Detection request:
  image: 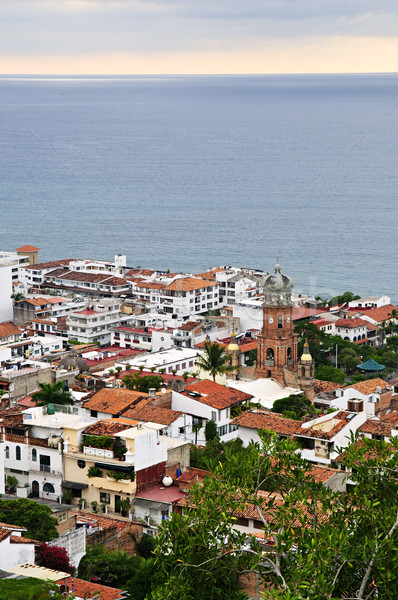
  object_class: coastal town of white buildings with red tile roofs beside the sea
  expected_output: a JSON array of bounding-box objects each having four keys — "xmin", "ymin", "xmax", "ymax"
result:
[{"xmin": 0, "ymin": 245, "xmax": 398, "ymax": 600}]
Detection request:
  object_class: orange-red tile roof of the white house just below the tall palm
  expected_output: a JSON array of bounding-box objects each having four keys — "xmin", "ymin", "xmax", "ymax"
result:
[{"xmin": 180, "ymin": 379, "xmax": 253, "ymax": 410}]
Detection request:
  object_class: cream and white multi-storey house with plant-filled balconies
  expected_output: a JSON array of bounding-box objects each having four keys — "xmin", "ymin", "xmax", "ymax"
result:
[{"xmin": 63, "ymin": 417, "xmax": 167, "ymax": 513}]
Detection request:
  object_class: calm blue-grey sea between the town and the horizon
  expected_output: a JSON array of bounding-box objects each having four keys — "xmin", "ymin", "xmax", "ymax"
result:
[{"xmin": 0, "ymin": 75, "xmax": 398, "ymax": 301}]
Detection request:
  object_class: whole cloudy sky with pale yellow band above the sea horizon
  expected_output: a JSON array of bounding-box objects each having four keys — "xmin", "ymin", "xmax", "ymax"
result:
[{"xmin": 0, "ymin": 0, "xmax": 398, "ymax": 74}]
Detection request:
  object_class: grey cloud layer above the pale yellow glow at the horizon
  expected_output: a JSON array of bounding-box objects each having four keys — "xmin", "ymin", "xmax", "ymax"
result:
[{"xmin": 0, "ymin": 0, "xmax": 398, "ymax": 71}]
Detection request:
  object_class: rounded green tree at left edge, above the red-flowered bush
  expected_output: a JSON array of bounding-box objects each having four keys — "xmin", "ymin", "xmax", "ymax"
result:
[{"xmin": 0, "ymin": 498, "xmax": 58, "ymax": 542}]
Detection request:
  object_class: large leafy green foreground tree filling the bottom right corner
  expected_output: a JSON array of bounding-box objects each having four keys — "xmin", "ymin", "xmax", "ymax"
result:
[{"xmin": 149, "ymin": 432, "xmax": 398, "ymax": 600}]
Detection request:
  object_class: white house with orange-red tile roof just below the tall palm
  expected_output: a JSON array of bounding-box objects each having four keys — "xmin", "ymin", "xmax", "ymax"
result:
[{"xmin": 172, "ymin": 379, "xmax": 253, "ymax": 444}]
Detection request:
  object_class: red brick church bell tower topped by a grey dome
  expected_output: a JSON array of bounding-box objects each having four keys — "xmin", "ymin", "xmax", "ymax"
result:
[{"xmin": 256, "ymin": 264, "xmax": 297, "ymax": 385}]
